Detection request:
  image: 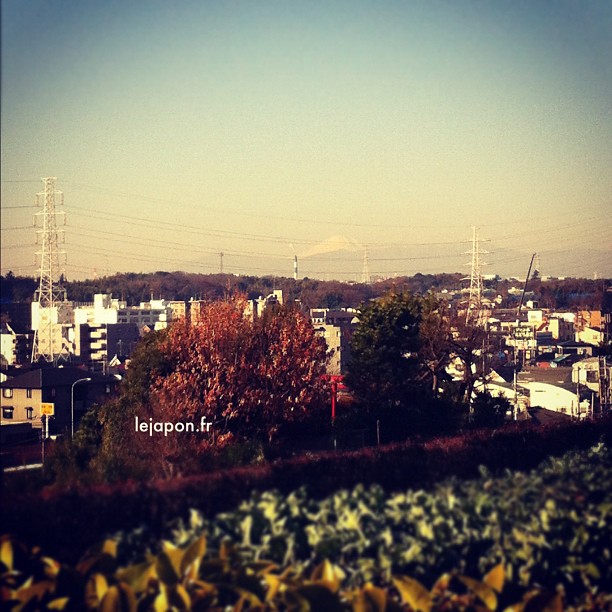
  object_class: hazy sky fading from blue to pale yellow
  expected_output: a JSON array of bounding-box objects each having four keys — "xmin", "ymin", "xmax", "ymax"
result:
[{"xmin": 0, "ymin": 0, "xmax": 612, "ymax": 281}]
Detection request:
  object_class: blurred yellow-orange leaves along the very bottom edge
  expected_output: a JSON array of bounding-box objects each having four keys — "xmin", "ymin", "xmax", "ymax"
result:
[{"xmin": 0, "ymin": 536, "xmax": 612, "ymax": 612}]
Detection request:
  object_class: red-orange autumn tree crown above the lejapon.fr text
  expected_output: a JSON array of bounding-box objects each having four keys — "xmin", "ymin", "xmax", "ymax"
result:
[{"xmin": 151, "ymin": 299, "xmax": 326, "ymax": 448}]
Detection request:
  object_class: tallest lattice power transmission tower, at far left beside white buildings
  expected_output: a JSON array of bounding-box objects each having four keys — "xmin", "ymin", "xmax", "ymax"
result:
[{"xmin": 32, "ymin": 177, "xmax": 68, "ymax": 362}]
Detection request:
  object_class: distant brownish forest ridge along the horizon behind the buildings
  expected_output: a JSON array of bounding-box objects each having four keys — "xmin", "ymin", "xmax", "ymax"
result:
[{"xmin": 0, "ymin": 272, "xmax": 612, "ymax": 309}]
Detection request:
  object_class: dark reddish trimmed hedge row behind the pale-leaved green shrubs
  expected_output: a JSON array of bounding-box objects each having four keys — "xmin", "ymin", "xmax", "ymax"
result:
[{"xmin": 0, "ymin": 419, "xmax": 612, "ymax": 561}]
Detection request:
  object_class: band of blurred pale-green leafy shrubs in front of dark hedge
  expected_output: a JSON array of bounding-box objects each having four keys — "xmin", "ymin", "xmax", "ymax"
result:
[{"xmin": 111, "ymin": 445, "xmax": 612, "ymax": 601}]
